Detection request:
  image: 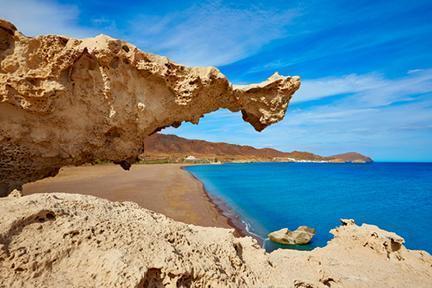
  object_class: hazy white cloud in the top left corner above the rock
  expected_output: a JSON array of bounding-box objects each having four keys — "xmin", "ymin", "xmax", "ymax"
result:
[{"xmin": 0, "ymin": 0, "xmax": 96, "ymax": 38}]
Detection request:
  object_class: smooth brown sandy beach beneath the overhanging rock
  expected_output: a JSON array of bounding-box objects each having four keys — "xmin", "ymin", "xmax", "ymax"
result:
[{"xmin": 23, "ymin": 164, "xmax": 235, "ymax": 228}]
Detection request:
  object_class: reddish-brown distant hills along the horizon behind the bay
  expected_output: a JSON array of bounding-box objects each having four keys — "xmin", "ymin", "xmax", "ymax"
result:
[{"xmin": 141, "ymin": 133, "xmax": 371, "ymax": 162}]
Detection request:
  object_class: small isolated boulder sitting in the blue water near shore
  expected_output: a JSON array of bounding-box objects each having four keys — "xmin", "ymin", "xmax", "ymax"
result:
[{"xmin": 268, "ymin": 226, "xmax": 315, "ymax": 245}]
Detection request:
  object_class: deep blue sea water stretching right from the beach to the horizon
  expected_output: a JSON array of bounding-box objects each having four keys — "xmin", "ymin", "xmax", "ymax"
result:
[{"xmin": 187, "ymin": 163, "xmax": 432, "ymax": 253}]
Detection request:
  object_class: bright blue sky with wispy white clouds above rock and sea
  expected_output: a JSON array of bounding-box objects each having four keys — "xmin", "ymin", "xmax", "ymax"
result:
[{"xmin": 0, "ymin": 0, "xmax": 432, "ymax": 161}]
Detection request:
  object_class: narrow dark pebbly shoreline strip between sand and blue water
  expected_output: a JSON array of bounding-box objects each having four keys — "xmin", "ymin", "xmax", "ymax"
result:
[{"xmin": 180, "ymin": 165, "xmax": 264, "ymax": 246}]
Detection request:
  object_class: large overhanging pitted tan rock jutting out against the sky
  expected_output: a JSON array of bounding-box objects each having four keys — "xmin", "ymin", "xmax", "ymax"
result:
[{"xmin": 0, "ymin": 20, "xmax": 300, "ymax": 195}]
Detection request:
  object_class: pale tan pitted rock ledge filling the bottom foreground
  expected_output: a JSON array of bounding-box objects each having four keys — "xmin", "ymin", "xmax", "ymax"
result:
[{"xmin": 0, "ymin": 193, "xmax": 432, "ymax": 287}]
